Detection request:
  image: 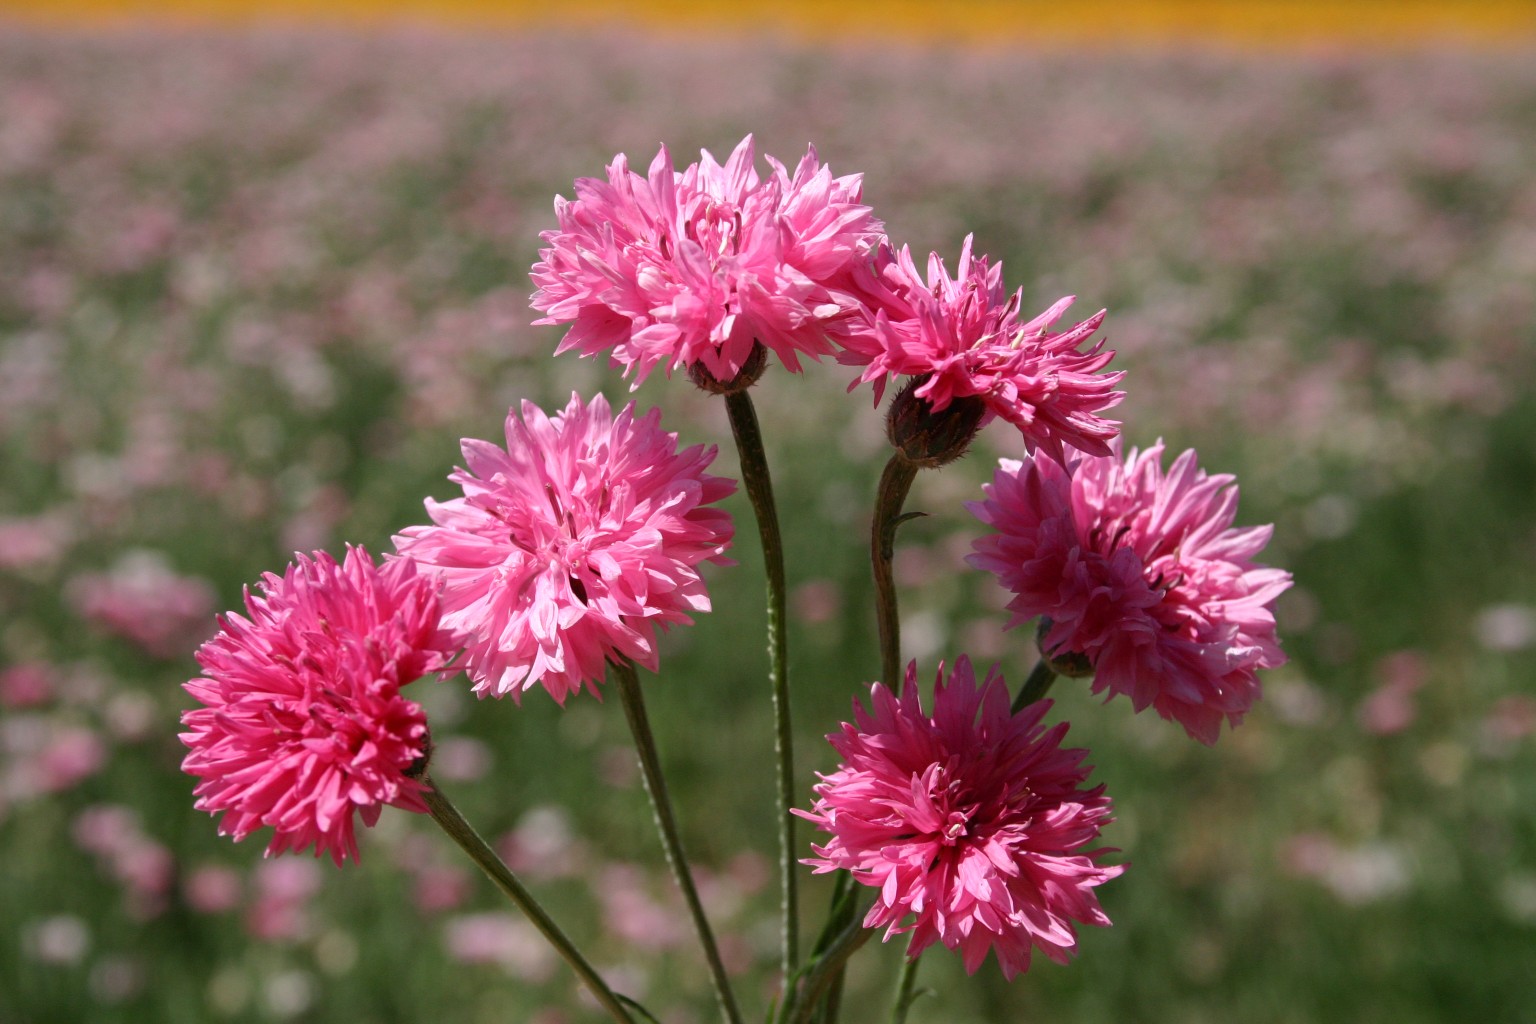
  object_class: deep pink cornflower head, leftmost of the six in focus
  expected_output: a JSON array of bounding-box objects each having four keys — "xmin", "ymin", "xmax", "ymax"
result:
[{"xmin": 181, "ymin": 548, "xmax": 453, "ymax": 864}]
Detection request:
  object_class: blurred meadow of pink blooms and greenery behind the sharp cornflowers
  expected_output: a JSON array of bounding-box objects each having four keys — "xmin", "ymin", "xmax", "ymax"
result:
[{"xmin": 0, "ymin": 23, "xmax": 1536, "ymax": 1024}]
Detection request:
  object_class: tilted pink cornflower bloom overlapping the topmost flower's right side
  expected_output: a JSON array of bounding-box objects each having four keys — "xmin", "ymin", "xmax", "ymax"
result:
[{"xmin": 837, "ymin": 236, "xmax": 1124, "ymax": 457}]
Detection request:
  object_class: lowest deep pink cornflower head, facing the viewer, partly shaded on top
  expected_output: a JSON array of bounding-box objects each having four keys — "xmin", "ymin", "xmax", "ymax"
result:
[{"xmin": 796, "ymin": 657, "xmax": 1124, "ymax": 978}]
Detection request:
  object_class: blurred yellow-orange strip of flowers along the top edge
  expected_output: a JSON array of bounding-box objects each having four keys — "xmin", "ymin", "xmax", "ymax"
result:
[{"xmin": 9, "ymin": 0, "xmax": 1536, "ymax": 48}]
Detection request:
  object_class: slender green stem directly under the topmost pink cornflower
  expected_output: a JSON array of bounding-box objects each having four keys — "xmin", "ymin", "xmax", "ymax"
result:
[{"xmin": 725, "ymin": 390, "xmax": 800, "ymax": 983}]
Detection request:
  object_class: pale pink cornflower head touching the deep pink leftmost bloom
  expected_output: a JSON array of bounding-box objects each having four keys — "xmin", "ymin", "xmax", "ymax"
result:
[{"xmin": 395, "ymin": 395, "xmax": 736, "ymax": 705}]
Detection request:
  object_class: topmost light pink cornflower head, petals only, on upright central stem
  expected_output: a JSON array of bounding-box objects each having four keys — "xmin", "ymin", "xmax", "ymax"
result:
[{"xmin": 531, "ymin": 135, "xmax": 882, "ymax": 385}]
